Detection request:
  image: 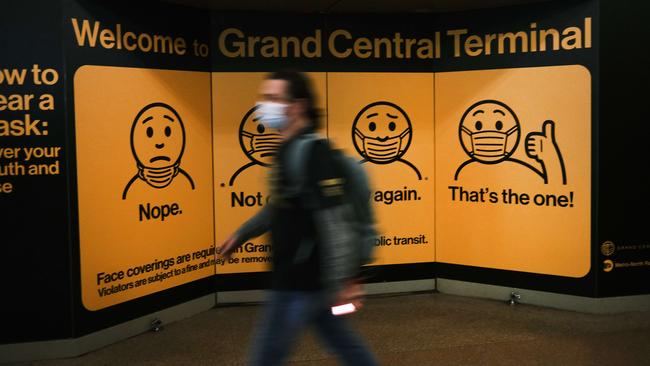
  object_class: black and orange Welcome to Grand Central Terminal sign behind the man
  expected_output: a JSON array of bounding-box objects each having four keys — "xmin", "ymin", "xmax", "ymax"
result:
[{"xmin": 55, "ymin": 0, "xmax": 597, "ymax": 311}]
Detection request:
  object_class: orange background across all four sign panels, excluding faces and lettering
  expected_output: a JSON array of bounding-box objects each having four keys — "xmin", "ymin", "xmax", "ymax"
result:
[{"xmin": 74, "ymin": 66, "xmax": 591, "ymax": 310}]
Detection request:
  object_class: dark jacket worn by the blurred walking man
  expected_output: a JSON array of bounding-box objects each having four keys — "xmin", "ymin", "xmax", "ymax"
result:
[{"xmin": 237, "ymin": 131, "xmax": 355, "ymax": 292}]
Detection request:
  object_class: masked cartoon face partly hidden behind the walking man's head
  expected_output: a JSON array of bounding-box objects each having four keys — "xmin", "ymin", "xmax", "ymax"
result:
[{"xmin": 239, "ymin": 106, "xmax": 282, "ymax": 166}]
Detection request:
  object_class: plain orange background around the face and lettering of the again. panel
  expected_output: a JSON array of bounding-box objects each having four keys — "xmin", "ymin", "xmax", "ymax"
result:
[{"xmin": 327, "ymin": 73, "xmax": 435, "ymax": 264}]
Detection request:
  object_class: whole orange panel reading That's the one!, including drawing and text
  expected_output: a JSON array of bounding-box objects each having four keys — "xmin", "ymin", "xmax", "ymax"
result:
[{"xmin": 435, "ymin": 66, "xmax": 592, "ymax": 277}]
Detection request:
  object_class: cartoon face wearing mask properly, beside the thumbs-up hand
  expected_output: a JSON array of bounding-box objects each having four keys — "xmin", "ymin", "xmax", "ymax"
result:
[{"xmin": 458, "ymin": 100, "xmax": 521, "ymax": 164}]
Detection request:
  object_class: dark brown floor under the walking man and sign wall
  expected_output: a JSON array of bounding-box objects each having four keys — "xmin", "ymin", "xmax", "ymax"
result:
[{"xmin": 8, "ymin": 293, "xmax": 650, "ymax": 366}]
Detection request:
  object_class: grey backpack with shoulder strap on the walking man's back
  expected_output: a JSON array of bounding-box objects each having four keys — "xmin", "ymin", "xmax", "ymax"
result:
[{"xmin": 287, "ymin": 133, "xmax": 377, "ymax": 267}]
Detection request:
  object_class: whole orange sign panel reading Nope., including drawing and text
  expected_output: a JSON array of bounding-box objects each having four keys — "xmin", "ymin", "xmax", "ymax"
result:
[{"xmin": 74, "ymin": 66, "xmax": 215, "ymax": 310}]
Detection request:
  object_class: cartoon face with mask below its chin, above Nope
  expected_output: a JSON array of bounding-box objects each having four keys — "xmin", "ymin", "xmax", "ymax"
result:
[{"xmin": 131, "ymin": 103, "xmax": 185, "ymax": 188}]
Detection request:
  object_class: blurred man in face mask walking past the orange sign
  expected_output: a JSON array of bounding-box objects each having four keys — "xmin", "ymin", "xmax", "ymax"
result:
[{"xmin": 219, "ymin": 71, "xmax": 377, "ymax": 366}]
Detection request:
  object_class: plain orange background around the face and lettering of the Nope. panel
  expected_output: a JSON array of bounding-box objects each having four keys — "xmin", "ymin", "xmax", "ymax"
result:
[{"xmin": 74, "ymin": 66, "xmax": 215, "ymax": 310}]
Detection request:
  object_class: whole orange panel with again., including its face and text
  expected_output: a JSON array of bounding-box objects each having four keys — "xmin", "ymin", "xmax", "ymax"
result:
[{"xmin": 327, "ymin": 73, "xmax": 435, "ymax": 265}]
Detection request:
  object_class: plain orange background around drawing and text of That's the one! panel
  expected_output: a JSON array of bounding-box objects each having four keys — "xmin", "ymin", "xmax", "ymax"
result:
[{"xmin": 435, "ymin": 66, "xmax": 591, "ymax": 277}]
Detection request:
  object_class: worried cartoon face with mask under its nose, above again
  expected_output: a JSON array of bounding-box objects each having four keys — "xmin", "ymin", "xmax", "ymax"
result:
[{"xmin": 352, "ymin": 101, "xmax": 412, "ymax": 164}]
